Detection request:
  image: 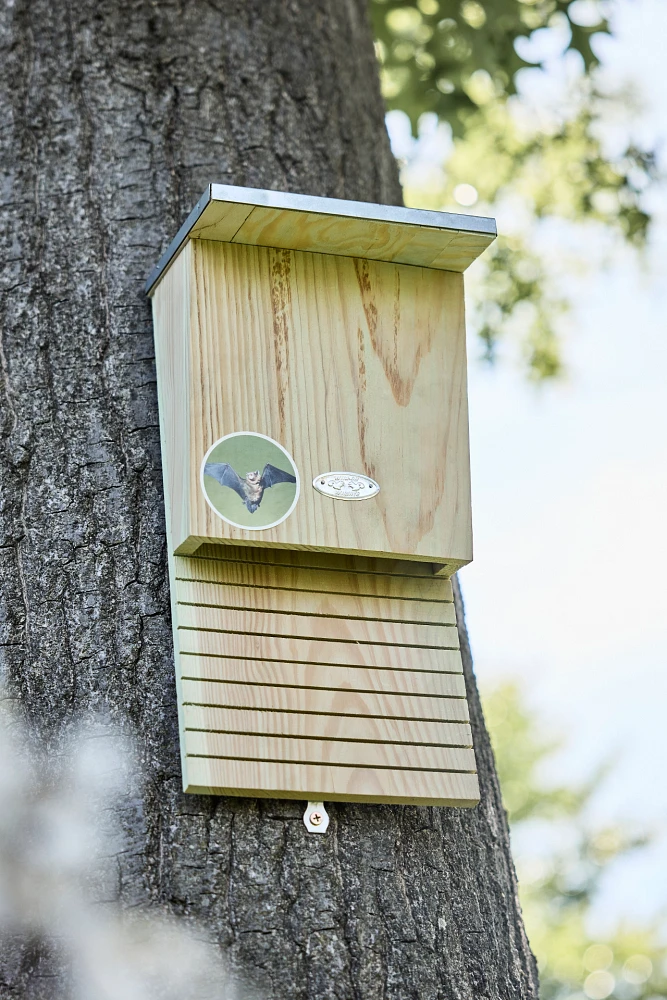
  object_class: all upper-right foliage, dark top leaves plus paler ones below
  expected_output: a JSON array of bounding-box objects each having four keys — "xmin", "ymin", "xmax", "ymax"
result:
[{"xmin": 371, "ymin": 0, "xmax": 656, "ymax": 380}]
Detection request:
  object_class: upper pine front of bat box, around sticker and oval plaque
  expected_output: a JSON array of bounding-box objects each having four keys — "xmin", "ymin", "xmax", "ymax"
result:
[{"xmin": 154, "ymin": 240, "xmax": 472, "ymax": 572}]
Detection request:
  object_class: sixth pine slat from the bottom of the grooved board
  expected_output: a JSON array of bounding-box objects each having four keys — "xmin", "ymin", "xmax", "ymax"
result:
[{"xmin": 178, "ymin": 627, "xmax": 458, "ymax": 671}]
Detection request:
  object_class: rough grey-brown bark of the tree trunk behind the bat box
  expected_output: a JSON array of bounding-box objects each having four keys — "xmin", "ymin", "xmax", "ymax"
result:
[{"xmin": 0, "ymin": 0, "xmax": 536, "ymax": 1000}]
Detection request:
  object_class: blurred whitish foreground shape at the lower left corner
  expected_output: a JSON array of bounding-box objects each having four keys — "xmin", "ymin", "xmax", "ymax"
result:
[{"xmin": 0, "ymin": 706, "xmax": 245, "ymax": 1000}]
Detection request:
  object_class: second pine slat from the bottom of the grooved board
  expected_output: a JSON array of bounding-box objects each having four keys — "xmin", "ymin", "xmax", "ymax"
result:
[{"xmin": 185, "ymin": 732, "xmax": 476, "ymax": 774}]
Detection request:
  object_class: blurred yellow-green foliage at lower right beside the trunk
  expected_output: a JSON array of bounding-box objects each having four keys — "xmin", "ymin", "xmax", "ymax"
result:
[{"xmin": 484, "ymin": 684, "xmax": 667, "ymax": 1000}]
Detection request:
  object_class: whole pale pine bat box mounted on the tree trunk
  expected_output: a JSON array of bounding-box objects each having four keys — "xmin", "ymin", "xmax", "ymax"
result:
[{"xmin": 147, "ymin": 185, "xmax": 495, "ymax": 805}]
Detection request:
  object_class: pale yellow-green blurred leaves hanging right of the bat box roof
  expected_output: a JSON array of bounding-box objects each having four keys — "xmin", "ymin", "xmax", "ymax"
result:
[{"xmin": 405, "ymin": 94, "xmax": 656, "ymax": 379}]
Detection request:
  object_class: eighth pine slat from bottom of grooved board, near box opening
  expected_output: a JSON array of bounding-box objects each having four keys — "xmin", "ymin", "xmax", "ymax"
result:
[{"xmin": 176, "ymin": 580, "xmax": 456, "ymax": 625}]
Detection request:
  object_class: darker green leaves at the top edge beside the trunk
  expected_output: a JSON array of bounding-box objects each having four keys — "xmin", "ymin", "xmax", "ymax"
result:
[{"xmin": 371, "ymin": 0, "xmax": 608, "ymax": 135}]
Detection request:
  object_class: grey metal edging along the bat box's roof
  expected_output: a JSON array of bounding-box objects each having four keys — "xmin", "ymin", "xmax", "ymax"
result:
[{"xmin": 145, "ymin": 184, "xmax": 498, "ymax": 295}]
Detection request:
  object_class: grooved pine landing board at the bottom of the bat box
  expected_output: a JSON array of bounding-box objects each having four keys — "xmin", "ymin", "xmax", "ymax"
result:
[{"xmin": 170, "ymin": 546, "xmax": 478, "ymax": 806}]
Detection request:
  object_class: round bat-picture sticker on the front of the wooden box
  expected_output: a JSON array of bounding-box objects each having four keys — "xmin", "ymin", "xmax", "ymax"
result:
[{"xmin": 201, "ymin": 431, "xmax": 299, "ymax": 531}]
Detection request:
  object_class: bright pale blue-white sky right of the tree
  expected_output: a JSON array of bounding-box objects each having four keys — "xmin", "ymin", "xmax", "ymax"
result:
[{"xmin": 388, "ymin": 0, "xmax": 667, "ymax": 922}]
